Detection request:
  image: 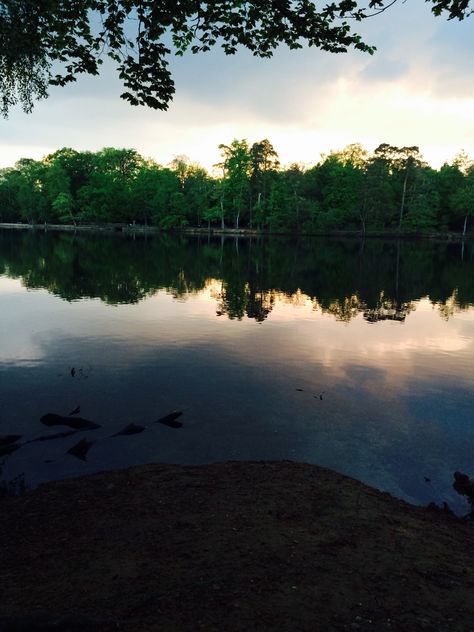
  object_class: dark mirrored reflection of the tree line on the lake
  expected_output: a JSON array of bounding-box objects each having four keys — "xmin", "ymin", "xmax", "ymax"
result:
[{"xmin": 0, "ymin": 231, "xmax": 474, "ymax": 322}]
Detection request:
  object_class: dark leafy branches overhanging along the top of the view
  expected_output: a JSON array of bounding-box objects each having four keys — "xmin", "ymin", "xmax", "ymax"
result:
[{"xmin": 0, "ymin": 0, "xmax": 472, "ymax": 116}]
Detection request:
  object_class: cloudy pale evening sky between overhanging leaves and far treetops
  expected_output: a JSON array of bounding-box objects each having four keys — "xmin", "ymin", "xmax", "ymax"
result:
[{"xmin": 0, "ymin": 0, "xmax": 474, "ymax": 171}]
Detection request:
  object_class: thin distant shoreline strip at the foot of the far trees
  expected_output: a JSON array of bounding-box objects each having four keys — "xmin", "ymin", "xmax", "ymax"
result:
[{"xmin": 0, "ymin": 222, "xmax": 474, "ymax": 242}]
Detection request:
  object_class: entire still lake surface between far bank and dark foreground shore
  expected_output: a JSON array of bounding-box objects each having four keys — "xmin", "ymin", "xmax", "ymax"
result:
[{"xmin": 0, "ymin": 230, "xmax": 474, "ymax": 511}]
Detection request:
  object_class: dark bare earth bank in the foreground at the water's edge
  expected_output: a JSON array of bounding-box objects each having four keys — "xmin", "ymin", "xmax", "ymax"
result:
[{"xmin": 0, "ymin": 461, "xmax": 474, "ymax": 632}]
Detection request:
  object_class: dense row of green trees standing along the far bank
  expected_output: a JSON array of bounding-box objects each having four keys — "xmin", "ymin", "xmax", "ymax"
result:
[{"xmin": 0, "ymin": 139, "xmax": 474, "ymax": 234}]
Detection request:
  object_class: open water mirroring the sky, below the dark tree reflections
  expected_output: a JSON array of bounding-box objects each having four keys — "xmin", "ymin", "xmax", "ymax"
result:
[{"xmin": 0, "ymin": 278, "xmax": 474, "ymax": 502}]
